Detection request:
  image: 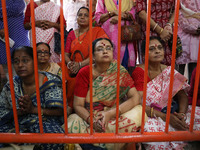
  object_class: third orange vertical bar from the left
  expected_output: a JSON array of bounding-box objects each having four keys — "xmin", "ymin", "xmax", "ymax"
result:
[{"xmin": 60, "ymin": 0, "xmax": 68, "ymax": 134}]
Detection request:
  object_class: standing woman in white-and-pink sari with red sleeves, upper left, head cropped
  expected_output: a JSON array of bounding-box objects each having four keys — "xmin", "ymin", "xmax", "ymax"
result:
[{"xmin": 24, "ymin": 0, "xmax": 66, "ymax": 63}]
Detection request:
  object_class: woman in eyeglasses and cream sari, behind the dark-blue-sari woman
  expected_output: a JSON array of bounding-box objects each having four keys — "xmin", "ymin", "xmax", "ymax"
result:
[{"xmin": 36, "ymin": 42, "xmax": 62, "ymax": 77}]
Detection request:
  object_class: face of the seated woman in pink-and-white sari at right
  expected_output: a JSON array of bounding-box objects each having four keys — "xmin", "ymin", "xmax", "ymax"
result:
[{"xmin": 149, "ymin": 39, "xmax": 165, "ymax": 62}]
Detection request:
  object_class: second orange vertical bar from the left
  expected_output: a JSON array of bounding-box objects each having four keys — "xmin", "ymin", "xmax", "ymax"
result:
[{"xmin": 30, "ymin": 0, "xmax": 43, "ymax": 133}]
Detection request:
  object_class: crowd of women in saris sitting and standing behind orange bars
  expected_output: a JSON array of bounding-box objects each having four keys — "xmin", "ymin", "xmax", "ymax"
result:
[{"xmin": 0, "ymin": 0, "xmax": 200, "ymax": 150}]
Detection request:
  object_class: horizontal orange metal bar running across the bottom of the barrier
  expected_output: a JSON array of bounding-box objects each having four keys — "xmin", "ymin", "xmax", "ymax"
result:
[{"xmin": 0, "ymin": 131, "xmax": 200, "ymax": 143}]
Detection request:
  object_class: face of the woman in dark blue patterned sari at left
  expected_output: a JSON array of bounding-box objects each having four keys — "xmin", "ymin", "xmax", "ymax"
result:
[{"xmin": 14, "ymin": 50, "xmax": 34, "ymax": 77}]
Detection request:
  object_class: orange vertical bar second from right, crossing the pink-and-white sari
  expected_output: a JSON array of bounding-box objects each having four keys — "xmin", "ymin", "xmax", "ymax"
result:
[{"xmin": 165, "ymin": 0, "xmax": 180, "ymax": 133}]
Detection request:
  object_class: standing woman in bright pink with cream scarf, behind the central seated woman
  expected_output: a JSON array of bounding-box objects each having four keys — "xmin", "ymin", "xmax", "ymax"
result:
[{"xmin": 95, "ymin": 0, "xmax": 136, "ymax": 69}]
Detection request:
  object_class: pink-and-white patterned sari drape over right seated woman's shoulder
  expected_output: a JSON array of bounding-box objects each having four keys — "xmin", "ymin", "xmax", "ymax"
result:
[{"xmin": 146, "ymin": 67, "xmax": 190, "ymax": 110}]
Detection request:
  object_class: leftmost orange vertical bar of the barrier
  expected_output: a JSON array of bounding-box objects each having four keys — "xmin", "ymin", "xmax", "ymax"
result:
[{"xmin": 1, "ymin": 0, "xmax": 19, "ymax": 134}]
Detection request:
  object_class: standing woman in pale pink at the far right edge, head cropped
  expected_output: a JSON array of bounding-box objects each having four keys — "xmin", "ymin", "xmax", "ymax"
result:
[{"xmin": 176, "ymin": 0, "xmax": 200, "ymax": 79}]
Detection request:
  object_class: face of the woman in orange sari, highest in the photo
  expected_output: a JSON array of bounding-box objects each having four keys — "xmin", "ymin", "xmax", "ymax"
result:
[{"xmin": 77, "ymin": 9, "xmax": 89, "ymax": 26}]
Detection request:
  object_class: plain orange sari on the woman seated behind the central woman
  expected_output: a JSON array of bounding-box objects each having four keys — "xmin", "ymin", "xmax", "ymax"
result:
[{"xmin": 66, "ymin": 27, "xmax": 108, "ymax": 108}]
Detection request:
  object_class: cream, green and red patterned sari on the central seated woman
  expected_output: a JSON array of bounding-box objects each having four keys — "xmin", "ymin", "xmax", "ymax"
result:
[{"xmin": 68, "ymin": 61, "xmax": 147, "ymax": 148}]
